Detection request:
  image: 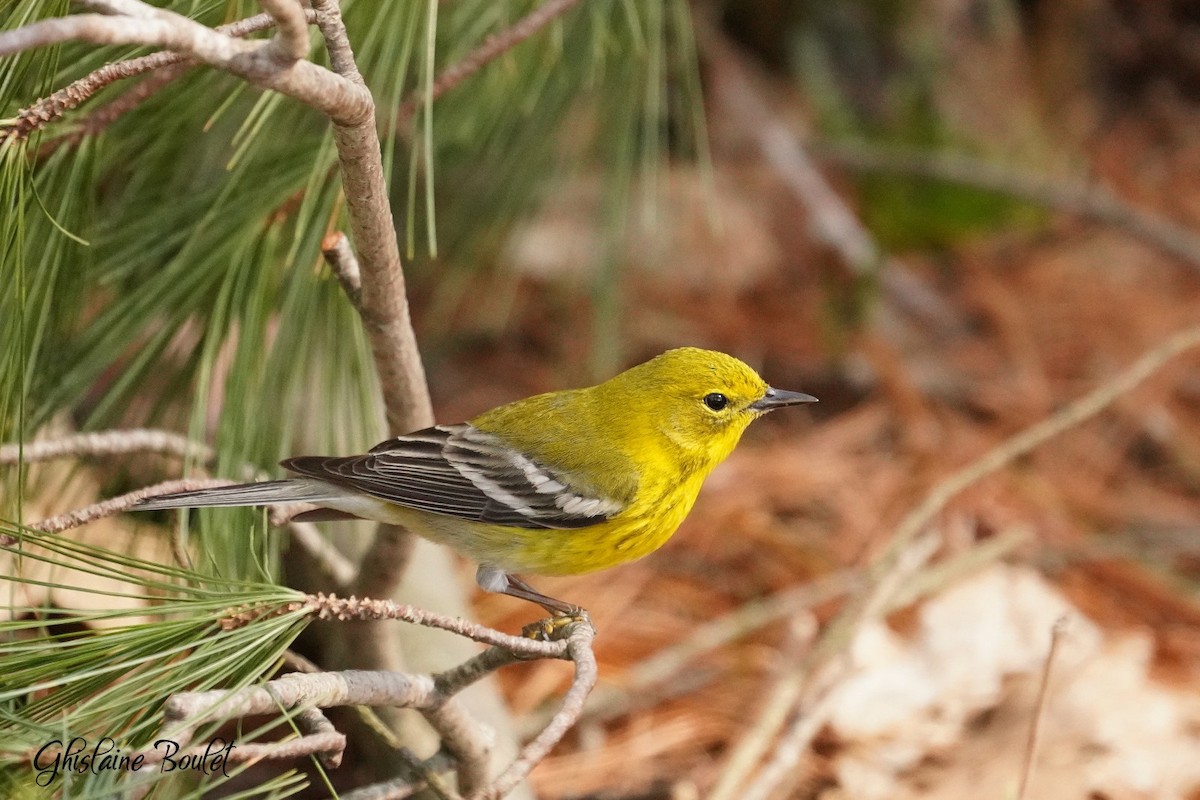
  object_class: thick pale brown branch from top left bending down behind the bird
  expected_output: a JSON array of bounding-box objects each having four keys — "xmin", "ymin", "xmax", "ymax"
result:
[{"xmin": 0, "ymin": 0, "xmax": 433, "ymax": 606}]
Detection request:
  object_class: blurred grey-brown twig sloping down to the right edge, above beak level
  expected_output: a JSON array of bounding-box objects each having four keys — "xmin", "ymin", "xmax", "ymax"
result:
[{"xmin": 814, "ymin": 143, "xmax": 1200, "ymax": 267}]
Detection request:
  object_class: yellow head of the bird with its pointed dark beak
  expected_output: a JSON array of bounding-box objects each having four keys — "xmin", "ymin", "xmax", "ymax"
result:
[{"xmin": 608, "ymin": 348, "xmax": 816, "ymax": 471}]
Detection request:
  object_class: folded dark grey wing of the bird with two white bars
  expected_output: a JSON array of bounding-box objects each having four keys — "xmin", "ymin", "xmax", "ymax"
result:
[{"xmin": 282, "ymin": 423, "xmax": 624, "ymax": 528}]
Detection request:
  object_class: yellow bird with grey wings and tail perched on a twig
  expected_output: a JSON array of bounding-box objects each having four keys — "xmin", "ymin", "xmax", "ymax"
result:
[{"xmin": 134, "ymin": 347, "xmax": 816, "ymax": 618}]
